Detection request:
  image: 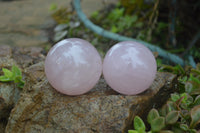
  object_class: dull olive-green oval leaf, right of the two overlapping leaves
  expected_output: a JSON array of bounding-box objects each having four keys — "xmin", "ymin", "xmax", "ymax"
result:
[{"xmin": 165, "ymin": 111, "xmax": 179, "ymax": 124}]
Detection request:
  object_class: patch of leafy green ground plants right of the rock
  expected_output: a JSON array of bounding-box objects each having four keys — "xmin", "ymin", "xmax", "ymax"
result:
[{"xmin": 128, "ymin": 64, "xmax": 200, "ymax": 133}]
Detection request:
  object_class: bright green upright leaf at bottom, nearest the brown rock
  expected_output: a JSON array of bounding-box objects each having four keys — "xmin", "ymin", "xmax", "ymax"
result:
[{"xmin": 134, "ymin": 116, "xmax": 145, "ymax": 132}]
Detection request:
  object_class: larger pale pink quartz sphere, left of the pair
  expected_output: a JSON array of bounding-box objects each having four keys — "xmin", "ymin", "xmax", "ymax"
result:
[{"xmin": 45, "ymin": 38, "xmax": 102, "ymax": 95}]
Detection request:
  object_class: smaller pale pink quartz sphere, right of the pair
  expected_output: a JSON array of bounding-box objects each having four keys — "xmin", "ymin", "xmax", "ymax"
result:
[{"xmin": 103, "ymin": 41, "xmax": 157, "ymax": 95}]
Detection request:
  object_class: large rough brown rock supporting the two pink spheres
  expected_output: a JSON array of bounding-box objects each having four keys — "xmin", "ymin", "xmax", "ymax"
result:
[{"xmin": 1, "ymin": 49, "xmax": 176, "ymax": 133}]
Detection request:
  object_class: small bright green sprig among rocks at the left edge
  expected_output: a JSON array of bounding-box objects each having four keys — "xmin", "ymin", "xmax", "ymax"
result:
[{"xmin": 0, "ymin": 65, "xmax": 25, "ymax": 88}]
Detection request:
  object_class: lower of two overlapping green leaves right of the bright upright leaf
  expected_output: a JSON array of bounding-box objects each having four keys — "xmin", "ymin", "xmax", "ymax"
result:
[{"xmin": 151, "ymin": 117, "xmax": 165, "ymax": 132}]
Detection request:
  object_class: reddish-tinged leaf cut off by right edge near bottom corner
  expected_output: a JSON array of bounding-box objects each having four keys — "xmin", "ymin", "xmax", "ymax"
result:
[{"xmin": 190, "ymin": 105, "xmax": 200, "ymax": 128}]
